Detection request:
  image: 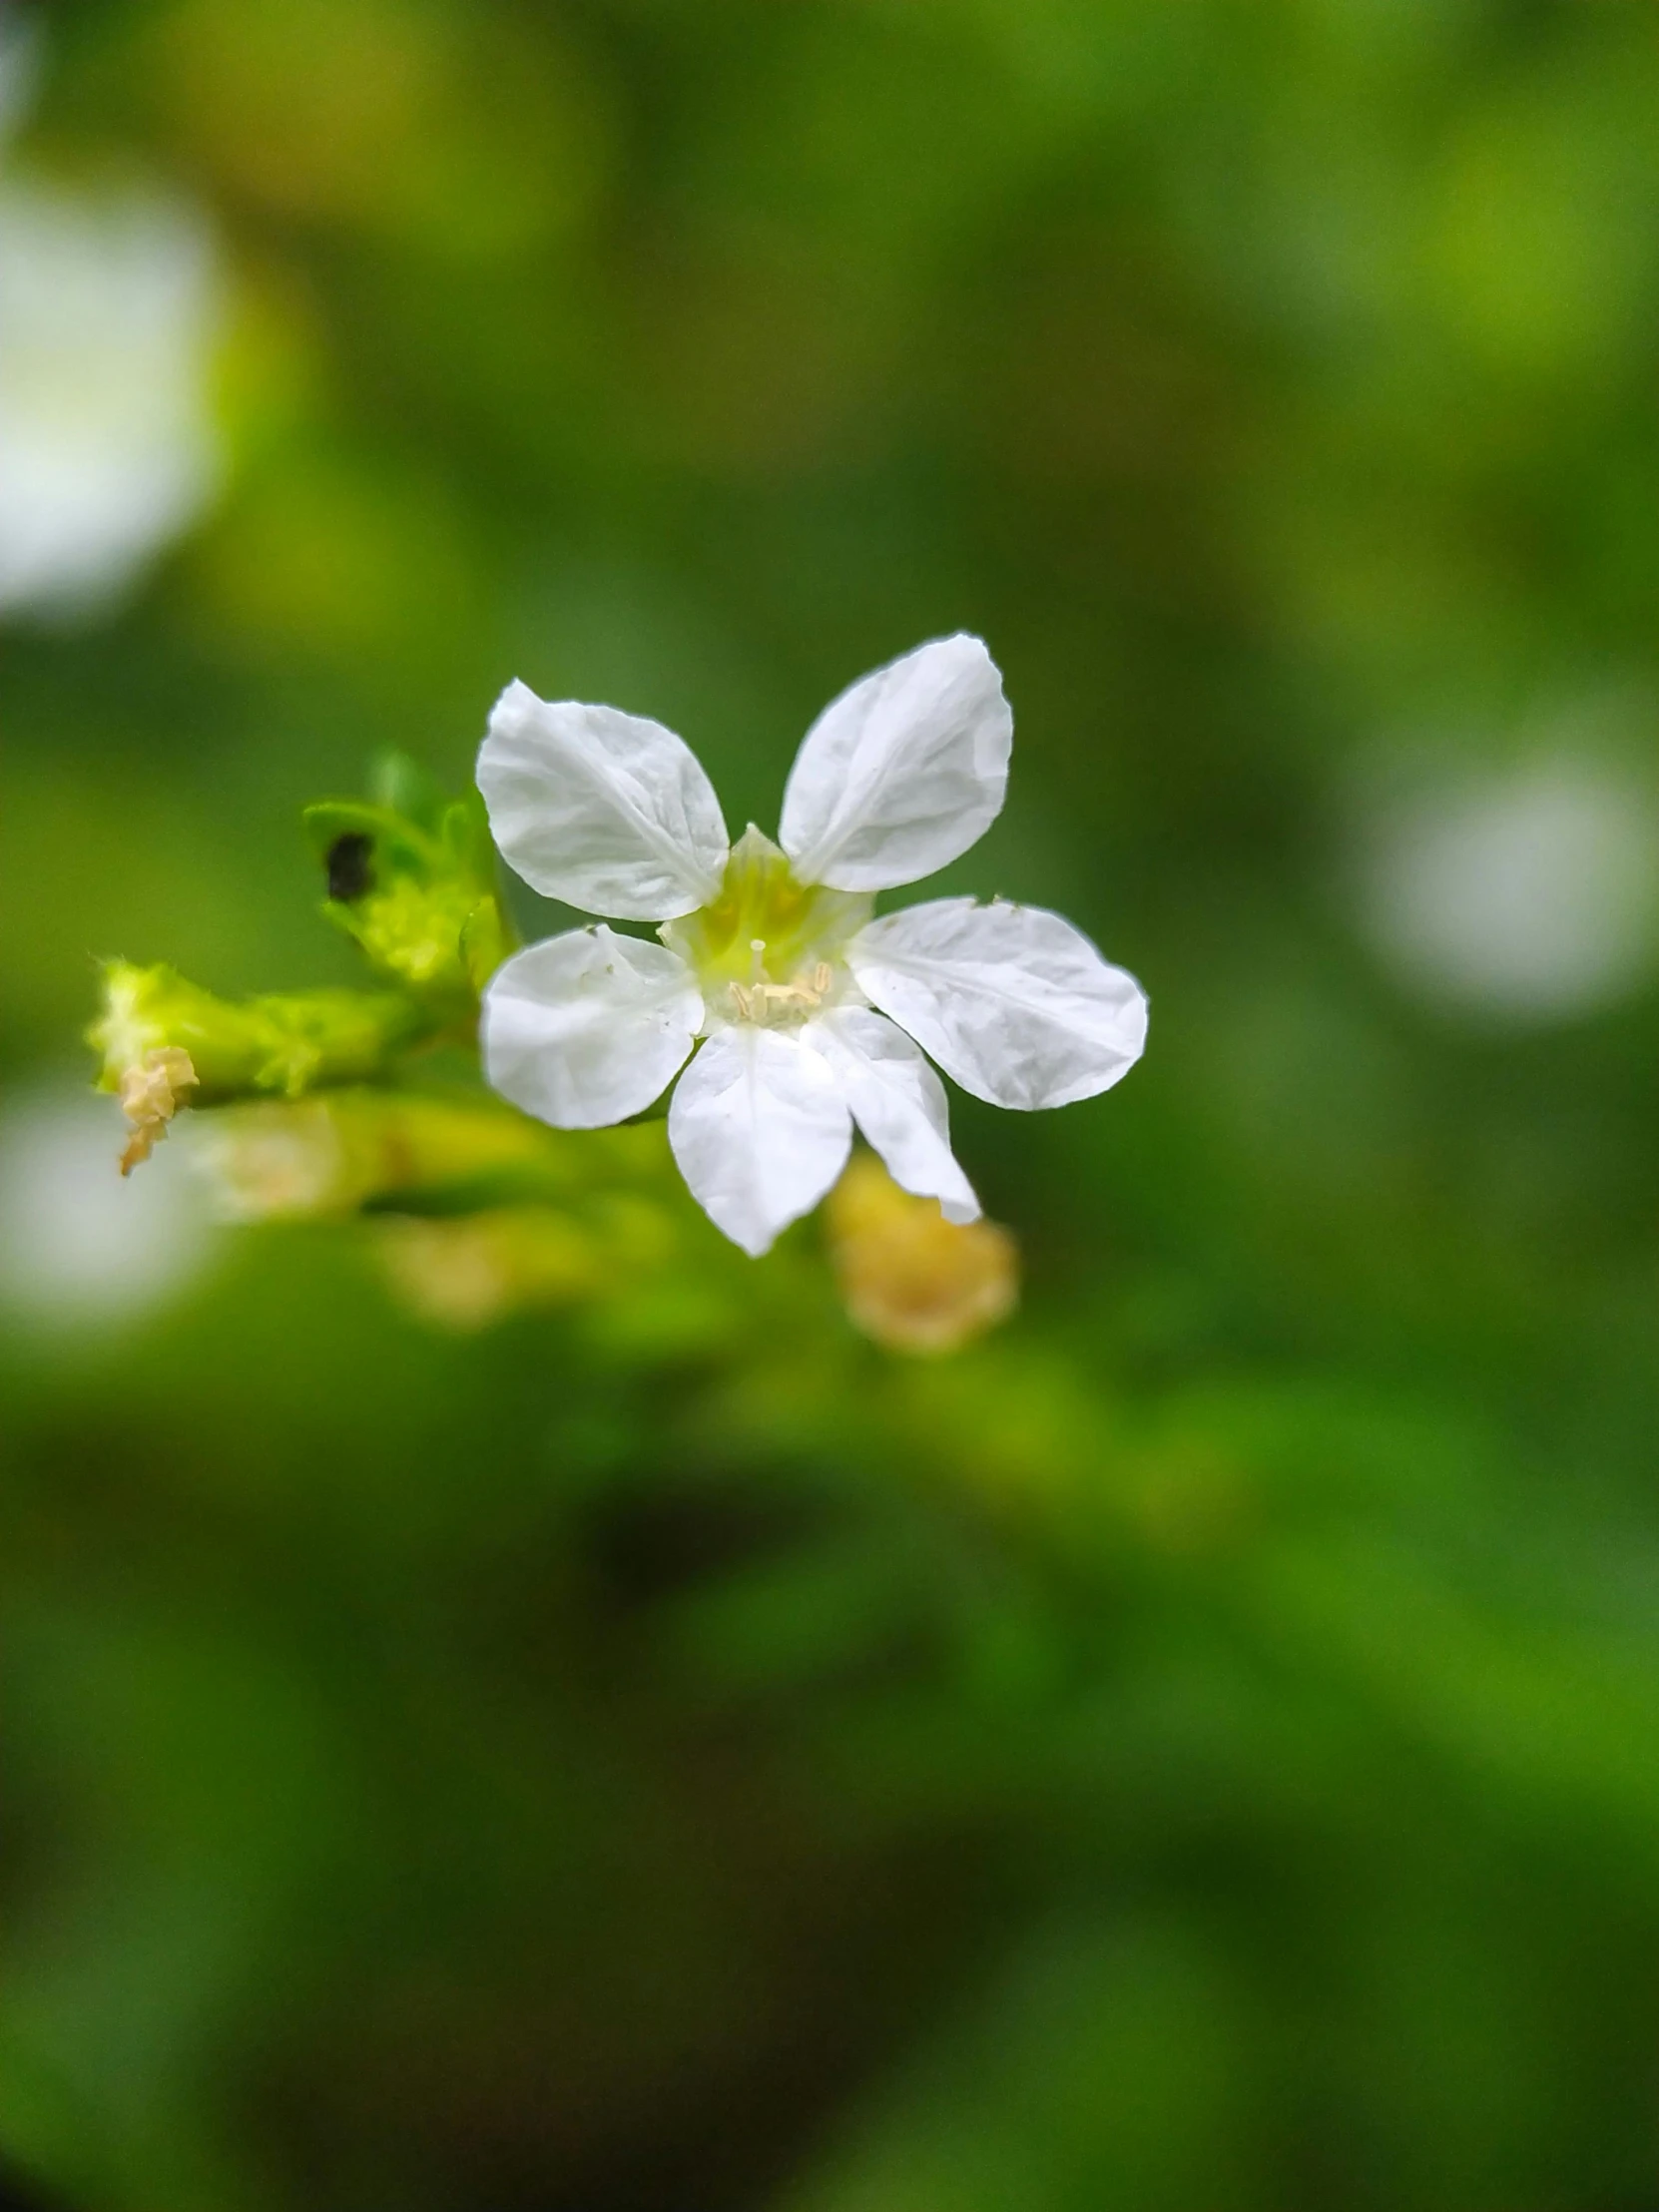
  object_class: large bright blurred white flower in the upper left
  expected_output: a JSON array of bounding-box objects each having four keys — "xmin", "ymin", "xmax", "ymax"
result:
[{"xmin": 0, "ymin": 16, "xmax": 219, "ymax": 613}]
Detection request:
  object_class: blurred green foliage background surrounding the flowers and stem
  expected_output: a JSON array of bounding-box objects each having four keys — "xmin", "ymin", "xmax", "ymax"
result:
[{"xmin": 0, "ymin": 0, "xmax": 1659, "ymax": 2212}]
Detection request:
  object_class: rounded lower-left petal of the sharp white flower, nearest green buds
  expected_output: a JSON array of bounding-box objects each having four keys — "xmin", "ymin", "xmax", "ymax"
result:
[{"xmin": 480, "ymin": 924, "xmax": 704, "ymax": 1128}]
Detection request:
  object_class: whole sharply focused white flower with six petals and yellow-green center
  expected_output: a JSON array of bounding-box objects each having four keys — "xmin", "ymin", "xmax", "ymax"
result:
[{"xmin": 478, "ymin": 637, "xmax": 1146, "ymax": 1254}]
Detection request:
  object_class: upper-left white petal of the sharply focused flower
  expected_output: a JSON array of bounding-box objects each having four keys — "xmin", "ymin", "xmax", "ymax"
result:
[{"xmin": 478, "ymin": 684, "xmax": 730, "ymax": 922}]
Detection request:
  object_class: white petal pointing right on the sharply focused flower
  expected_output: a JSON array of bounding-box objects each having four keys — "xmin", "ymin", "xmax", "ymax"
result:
[{"xmin": 847, "ymin": 898, "xmax": 1146, "ymax": 1108}]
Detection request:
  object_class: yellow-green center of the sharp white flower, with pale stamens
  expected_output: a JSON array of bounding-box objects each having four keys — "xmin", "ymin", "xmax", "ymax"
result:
[{"xmin": 659, "ymin": 823, "xmax": 871, "ymax": 1026}]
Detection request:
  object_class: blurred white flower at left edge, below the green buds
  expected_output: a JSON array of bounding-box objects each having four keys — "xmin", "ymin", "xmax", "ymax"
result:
[{"xmin": 0, "ymin": 1090, "xmax": 213, "ymax": 1330}]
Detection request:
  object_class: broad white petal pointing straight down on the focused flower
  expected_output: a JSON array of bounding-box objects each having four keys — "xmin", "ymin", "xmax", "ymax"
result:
[{"xmin": 668, "ymin": 1022, "xmax": 851, "ymax": 1259}]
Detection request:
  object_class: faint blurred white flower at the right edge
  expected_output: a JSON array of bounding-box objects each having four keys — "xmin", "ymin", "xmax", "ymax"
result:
[{"xmin": 1363, "ymin": 752, "xmax": 1659, "ymax": 1022}]
